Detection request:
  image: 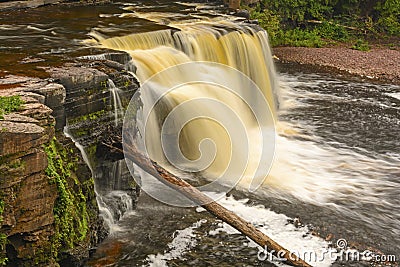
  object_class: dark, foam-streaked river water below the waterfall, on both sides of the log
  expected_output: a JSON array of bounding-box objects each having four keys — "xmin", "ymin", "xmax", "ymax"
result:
[{"xmin": 89, "ymin": 61, "xmax": 400, "ymax": 266}]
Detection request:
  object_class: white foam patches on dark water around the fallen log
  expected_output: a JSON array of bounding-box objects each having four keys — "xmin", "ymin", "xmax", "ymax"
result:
[{"xmin": 147, "ymin": 195, "xmax": 336, "ymax": 267}]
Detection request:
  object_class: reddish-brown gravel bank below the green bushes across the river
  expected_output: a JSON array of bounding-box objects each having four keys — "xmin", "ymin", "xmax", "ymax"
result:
[{"xmin": 273, "ymin": 47, "xmax": 400, "ymax": 84}]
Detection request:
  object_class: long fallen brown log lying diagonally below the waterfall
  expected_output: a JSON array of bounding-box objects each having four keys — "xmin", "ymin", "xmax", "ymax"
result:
[{"xmin": 103, "ymin": 136, "xmax": 311, "ymax": 267}]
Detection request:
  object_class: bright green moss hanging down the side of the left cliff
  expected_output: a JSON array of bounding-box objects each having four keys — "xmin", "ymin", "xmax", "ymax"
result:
[{"xmin": 45, "ymin": 138, "xmax": 89, "ymax": 258}]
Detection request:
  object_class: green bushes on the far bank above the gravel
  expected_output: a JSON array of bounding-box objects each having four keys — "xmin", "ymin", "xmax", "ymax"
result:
[{"xmin": 248, "ymin": 0, "xmax": 400, "ymax": 49}]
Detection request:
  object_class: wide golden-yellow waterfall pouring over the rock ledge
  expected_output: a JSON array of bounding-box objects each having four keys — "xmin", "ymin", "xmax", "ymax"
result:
[{"xmin": 97, "ymin": 21, "xmax": 278, "ymax": 205}]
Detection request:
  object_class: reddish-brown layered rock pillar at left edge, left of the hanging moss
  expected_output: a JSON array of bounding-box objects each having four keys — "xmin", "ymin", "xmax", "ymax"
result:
[{"xmin": 0, "ymin": 77, "xmax": 57, "ymax": 265}]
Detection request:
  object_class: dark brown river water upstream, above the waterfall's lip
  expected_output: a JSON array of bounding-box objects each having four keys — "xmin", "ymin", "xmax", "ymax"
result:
[{"xmin": 0, "ymin": 0, "xmax": 174, "ymax": 76}]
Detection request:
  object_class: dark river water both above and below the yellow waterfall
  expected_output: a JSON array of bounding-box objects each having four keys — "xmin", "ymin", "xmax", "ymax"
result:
[{"xmin": 0, "ymin": 1, "xmax": 400, "ymax": 266}]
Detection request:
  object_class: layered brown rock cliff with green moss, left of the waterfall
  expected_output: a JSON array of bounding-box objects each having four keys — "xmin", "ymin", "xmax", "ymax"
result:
[{"xmin": 0, "ymin": 55, "xmax": 137, "ymax": 266}]
